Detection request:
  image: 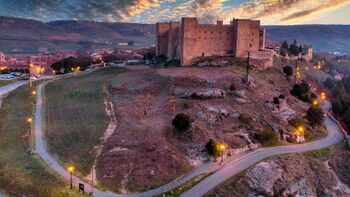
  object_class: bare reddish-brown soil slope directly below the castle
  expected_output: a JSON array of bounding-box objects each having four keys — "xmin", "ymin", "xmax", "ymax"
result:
[{"xmin": 97, "ymin": 66, "xmax": 318, "ymax": 193}]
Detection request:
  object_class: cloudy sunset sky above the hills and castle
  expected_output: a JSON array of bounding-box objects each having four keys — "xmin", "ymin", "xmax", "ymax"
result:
[{"xmin": 0, "ymin": 0, "xmax": 350, "ymax": 25}]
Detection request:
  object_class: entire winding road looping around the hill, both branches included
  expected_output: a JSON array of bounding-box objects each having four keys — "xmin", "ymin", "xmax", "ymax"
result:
[{"xmin": 32, "ymin": 73, "xmax": 344, "ymax": 197}]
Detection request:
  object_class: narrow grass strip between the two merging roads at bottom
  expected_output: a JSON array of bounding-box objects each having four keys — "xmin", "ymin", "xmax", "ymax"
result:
[{"xmin": 157, "ymin": 173, "xmax": 212, "ymax": 197}]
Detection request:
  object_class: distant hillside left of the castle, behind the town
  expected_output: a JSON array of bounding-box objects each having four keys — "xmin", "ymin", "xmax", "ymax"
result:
[{"xmin": 0, "ymin": 17, "xmax": 155, "ymax": 53}]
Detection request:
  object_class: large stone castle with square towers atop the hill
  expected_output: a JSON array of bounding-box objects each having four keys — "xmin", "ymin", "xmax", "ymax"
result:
[{"xmin": 156, "ymin": 17, "xmax": 265, "ymax": 66}]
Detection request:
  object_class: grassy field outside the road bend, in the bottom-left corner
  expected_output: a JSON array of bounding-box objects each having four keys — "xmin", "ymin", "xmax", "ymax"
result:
[{"xmin": 0, "ymin": 82, "xmax": 76, "ymax": 197}]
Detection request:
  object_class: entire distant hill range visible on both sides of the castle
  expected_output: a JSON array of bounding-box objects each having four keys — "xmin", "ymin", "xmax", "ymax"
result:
[{"xmin": 0, "ymin": 17, "xmax": 350, "ymax": 53}]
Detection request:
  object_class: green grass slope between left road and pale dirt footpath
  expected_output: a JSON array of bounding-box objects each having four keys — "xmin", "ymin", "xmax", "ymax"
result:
[{"xmin": 44, "ymin": 67, "xmax": 125, "ymax": 176}]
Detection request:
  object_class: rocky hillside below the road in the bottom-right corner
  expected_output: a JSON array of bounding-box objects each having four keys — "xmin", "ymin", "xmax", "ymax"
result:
[{"xmin": 207, "ymin": 145, "xmax": 350, "ymax": 197}]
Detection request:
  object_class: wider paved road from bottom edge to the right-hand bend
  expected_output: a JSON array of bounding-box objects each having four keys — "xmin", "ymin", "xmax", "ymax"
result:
[{"xmin": 181, "ymin": 101, "xmax": 344, "ymax": 197}]
